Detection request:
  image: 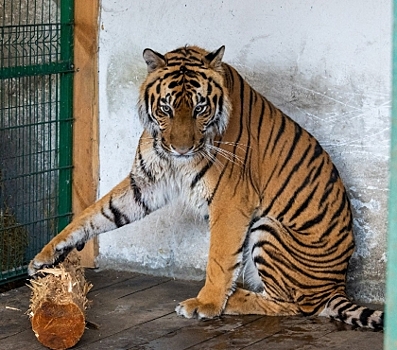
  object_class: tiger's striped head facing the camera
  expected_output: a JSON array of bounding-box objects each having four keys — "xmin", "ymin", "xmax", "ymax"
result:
[{"xmin": 138, "ymin": 46, "xmax": 230, "ymax": 159}]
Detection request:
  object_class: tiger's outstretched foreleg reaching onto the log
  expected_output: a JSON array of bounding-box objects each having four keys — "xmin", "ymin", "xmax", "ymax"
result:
[{"xmin": 28, "ymin": 175, "xmax": 161, "ymax": 275}]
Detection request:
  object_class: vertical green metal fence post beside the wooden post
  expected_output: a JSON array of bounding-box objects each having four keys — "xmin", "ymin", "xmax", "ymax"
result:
[{"xmin": 58, "ymin": 0, "xmax": 74, "ymax": 231}]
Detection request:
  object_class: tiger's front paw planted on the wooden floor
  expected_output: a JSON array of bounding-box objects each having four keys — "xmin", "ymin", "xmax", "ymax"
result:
[{"xmin": 175, "ymin": 298, "xmax": 222, "ymax": 319}]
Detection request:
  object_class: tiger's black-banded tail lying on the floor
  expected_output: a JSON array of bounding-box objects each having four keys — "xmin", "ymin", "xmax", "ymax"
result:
[{"xmin": 320, "ymin": 294, "xmax": 384, "ymax": 330}]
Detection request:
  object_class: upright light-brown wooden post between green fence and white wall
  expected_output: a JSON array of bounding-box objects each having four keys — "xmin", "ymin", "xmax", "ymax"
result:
[{"xmin": 72, "ymin": 0, "xmax": 99, "ymax": 267}]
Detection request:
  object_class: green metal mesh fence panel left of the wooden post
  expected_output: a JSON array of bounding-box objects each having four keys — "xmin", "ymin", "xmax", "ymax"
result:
[{"xmin": 0, "ymin": 0, "xmax": 73, "ymax": 284}]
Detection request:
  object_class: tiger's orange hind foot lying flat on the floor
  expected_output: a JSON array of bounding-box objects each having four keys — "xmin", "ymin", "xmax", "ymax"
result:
[{"xmin": 223, "ymin": 288, "xmax": 301, "ymax": 316}]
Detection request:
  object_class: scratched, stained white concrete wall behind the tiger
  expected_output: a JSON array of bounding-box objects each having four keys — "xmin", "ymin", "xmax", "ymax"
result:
[{"xmin": 99, "ymin": 0, "xmax": 392, "ymax": 301}]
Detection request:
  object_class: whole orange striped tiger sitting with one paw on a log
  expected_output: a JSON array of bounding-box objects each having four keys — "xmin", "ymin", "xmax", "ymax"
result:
[{"xmin": 28, "ymin": 46, "xmax": 384, "ymax": 330}]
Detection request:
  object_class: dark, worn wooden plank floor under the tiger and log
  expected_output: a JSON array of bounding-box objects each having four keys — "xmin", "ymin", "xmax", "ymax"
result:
[{"xmin": 0, "ymin": 271, "xmax": 383, "ymax": 350}]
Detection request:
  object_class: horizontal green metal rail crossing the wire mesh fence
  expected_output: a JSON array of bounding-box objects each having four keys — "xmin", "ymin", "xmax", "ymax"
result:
[{"xmin": 0, "ymin": 60, "xmax": 73, "ymax": 79}]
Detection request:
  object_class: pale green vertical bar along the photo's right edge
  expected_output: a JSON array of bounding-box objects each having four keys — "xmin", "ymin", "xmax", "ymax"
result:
[{"xmin": 384, "ymin": 0, "xmax": 397, "ymax": 350}]
